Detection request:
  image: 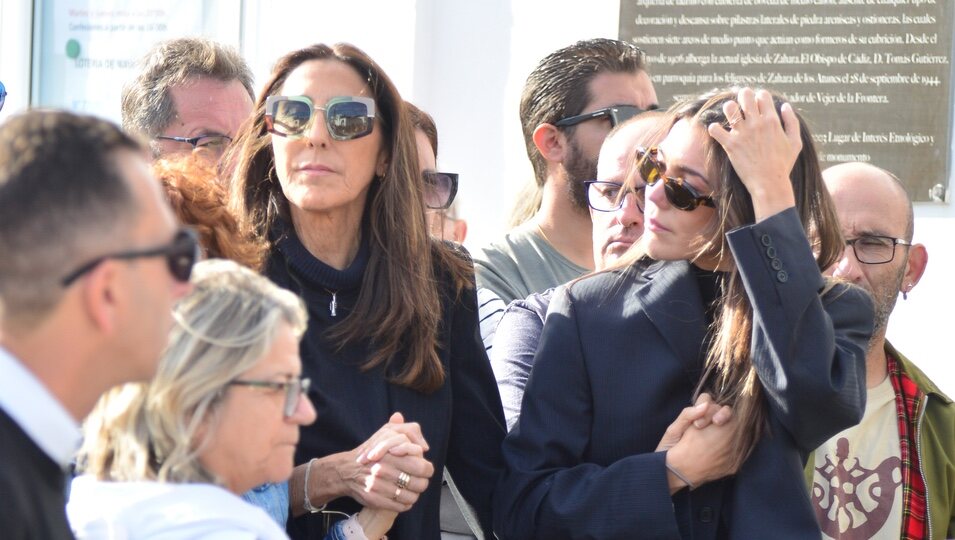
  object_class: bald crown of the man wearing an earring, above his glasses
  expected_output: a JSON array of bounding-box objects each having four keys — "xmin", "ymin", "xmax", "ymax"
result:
[{"xmin": 822, "ymin": 162, "xmax": 915, "ymax": 241}]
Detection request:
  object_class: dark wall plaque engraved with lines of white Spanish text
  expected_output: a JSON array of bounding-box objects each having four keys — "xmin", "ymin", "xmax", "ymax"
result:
[{"xmin": 620, "ymin": 0, "xmax": 955, "ymax": 202}]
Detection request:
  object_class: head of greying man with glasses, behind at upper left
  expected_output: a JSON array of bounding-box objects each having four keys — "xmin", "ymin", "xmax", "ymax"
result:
[{"xmin": 122, "ymin": 37, "xmax": 255, "ymax": 160}]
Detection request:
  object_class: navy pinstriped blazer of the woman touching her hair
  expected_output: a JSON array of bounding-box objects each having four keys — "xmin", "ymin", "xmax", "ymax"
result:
[{"xmin": 495, "ymin": 210, "xmax": 872, "ymax": 540}]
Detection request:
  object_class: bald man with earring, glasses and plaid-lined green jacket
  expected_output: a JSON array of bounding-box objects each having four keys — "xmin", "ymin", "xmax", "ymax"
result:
[{"xmin": 806, "ymin": 163, "xmax": 955, "ymax": 539}]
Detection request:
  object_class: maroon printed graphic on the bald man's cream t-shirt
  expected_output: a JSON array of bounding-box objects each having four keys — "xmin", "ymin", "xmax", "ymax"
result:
[{"xmin": 812, "ymin": 437, "xmax": 902, "ymax": 540}]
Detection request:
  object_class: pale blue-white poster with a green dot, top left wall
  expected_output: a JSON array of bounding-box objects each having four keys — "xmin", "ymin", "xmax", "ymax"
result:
[{"xmin": 32, "ymin": 0, "xmax": 239, "ymax": 122}]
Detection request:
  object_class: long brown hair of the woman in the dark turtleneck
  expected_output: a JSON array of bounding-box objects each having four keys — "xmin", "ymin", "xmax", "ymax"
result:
[{"xmin": 229, "ymin": 43, "xmax": 473, "ymax": 392}]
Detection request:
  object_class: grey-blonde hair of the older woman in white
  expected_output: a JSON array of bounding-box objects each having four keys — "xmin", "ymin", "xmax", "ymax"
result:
[{"xmin": 80, "ymin": 259, "xmax": 307, "ymax": 483}]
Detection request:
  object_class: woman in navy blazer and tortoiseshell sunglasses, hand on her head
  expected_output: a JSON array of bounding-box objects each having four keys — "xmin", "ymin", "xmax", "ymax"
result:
[{"xmin": 495, "ymin": 89, "xmax": 872, "ymax": 540}]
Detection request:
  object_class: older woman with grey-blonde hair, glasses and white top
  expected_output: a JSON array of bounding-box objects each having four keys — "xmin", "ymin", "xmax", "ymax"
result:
[{"xmin": 67, "ymin": 260, "xmax": 394, "ymax": 539}]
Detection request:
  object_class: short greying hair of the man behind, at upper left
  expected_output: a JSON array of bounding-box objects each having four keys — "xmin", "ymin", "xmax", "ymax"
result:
[{"xmin": 122, "ymin": 37, "xmax": 255, "ymax": 139}]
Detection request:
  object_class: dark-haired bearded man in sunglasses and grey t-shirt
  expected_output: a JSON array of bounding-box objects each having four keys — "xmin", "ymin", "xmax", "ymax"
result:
[{"xmin": 474, "ymin": 39, "xmax": 657, "ymax": 345}]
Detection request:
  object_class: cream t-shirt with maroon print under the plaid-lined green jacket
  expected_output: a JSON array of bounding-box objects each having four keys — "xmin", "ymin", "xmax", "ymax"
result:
[{"xmin": 811, "ymin": 377, "xmax": 902, "ymax": 540}]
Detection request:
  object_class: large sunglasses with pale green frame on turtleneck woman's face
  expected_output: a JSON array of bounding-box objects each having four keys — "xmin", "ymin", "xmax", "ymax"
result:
[{"xmin": 265, "ymin": 96, "xmax": 375, "ymax": 141}]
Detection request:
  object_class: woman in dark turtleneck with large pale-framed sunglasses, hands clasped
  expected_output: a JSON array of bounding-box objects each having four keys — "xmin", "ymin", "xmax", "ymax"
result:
[{"xmin": 225, "ymin": 44, "xmax": 504, "ymax": 539}]
